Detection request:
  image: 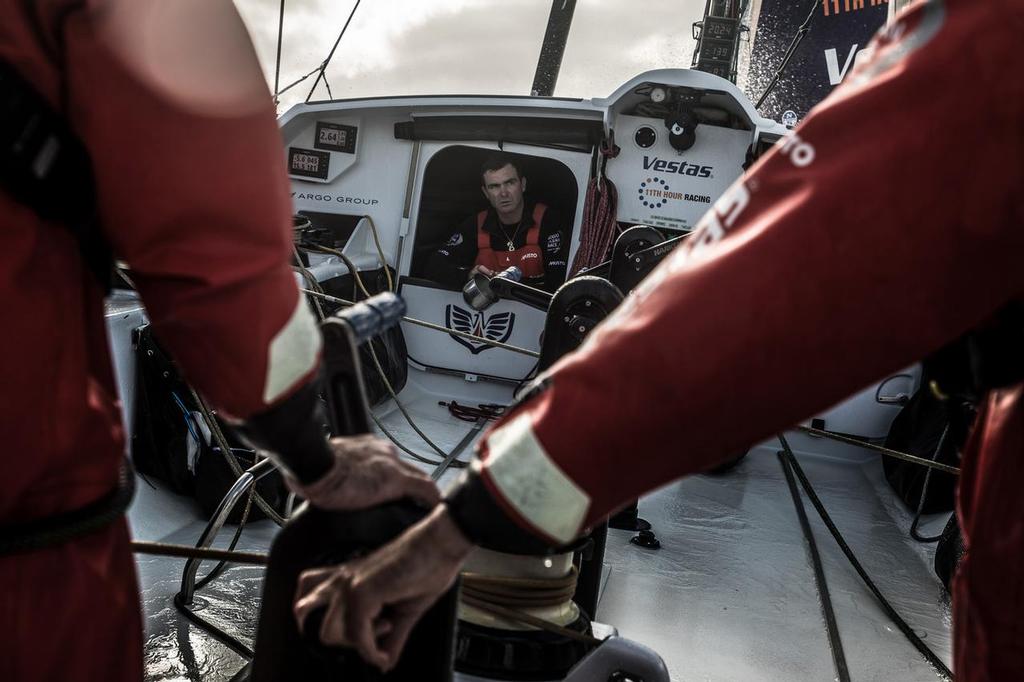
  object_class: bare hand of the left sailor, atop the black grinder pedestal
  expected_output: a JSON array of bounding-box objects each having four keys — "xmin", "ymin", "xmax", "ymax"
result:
[{"xmin": 289, "ymin": 434, "xmax": 440, "ymax": 511}]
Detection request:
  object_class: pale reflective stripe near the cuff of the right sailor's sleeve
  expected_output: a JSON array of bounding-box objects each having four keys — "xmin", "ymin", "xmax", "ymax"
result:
[{"xmin": 481, "ymin": 415, "xmax": 590, "ymax": 544}]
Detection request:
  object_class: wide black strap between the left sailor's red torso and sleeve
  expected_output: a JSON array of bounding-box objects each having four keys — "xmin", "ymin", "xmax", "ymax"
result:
[{"xmin": 0, "ymin": 59, "xmax": 114, "ymax": 293}]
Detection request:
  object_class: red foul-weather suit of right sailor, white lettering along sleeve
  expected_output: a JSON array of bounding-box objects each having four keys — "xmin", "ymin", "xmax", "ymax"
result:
[{"xmin": 449, "ymin": 0, "xmax": 1024, "ymax": 682}]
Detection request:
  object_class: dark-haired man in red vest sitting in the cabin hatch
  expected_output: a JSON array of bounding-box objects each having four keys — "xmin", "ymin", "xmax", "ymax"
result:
[{"xmin": 427, "ymin": 153, "xmax": 571, "ymax": 292}]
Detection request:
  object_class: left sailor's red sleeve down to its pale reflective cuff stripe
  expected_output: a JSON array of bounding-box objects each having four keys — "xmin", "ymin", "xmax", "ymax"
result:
[{"xmin": 63, "ymin": 0, "xmax": 319, "ymax": 417}]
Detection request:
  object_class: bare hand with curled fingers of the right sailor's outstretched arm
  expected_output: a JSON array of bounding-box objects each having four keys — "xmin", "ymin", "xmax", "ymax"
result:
[{"xmin": 294, "ymin": 507, "xmax": 472, "ymax": 671}]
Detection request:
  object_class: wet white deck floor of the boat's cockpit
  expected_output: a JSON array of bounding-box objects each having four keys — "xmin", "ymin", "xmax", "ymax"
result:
[{"xmin": 130, "ymin": 371, "xmax": 950, "ymax": 682}]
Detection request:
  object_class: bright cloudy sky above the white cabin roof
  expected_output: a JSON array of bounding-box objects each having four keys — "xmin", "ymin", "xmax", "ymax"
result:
[{"xmin": 234, "ymin": 0, "xmax": 705, "ymax": 111}]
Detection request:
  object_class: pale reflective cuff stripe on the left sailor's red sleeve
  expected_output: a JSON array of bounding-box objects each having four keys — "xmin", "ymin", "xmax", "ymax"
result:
[{"xmin": 263, "ymin": 293, "xmax": 324, "ymax": 404}]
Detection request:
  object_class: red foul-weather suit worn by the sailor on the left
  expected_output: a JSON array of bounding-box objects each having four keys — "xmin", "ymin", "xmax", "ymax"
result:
[{"xmin": 0, "ymin": 0, "xmax": 319, "ymax": 682}]
